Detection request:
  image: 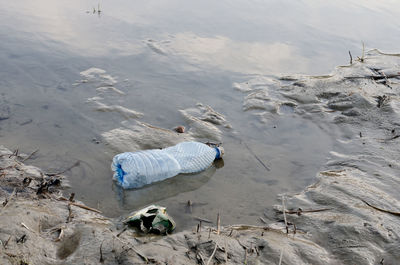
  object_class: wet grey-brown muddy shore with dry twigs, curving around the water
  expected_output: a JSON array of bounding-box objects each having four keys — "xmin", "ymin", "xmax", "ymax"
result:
[{"xmin": 0, "ymin": 50, "xmax": 400, "ymax": 264}]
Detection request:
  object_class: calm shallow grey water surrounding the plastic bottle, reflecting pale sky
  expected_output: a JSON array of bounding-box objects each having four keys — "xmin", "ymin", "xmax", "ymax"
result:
[{"xmin": 0, "ymin": 1, "xmax": 400, "ymax": 228}]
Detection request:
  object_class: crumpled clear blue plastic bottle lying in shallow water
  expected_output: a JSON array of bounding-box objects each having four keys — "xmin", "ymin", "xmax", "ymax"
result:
[{"xmin": 111, "ymin": 142, "xmax": 224, "ymax": 189}]
